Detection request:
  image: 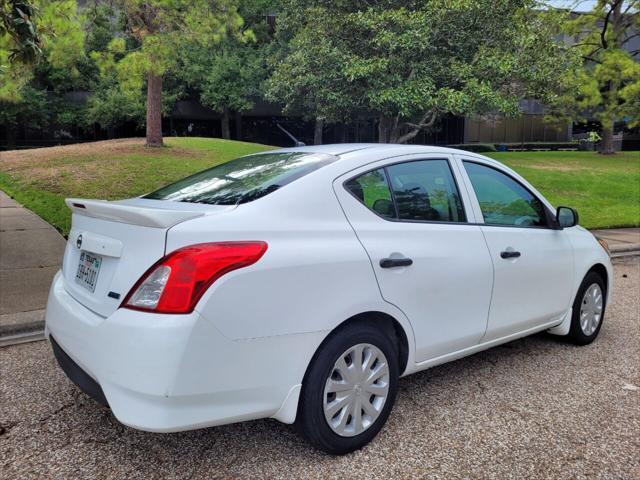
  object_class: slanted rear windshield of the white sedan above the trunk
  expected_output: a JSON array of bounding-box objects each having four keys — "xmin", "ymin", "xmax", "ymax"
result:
[{"xmin": 143, "ymin": 152, "xmax": 337, "ymax": 205}]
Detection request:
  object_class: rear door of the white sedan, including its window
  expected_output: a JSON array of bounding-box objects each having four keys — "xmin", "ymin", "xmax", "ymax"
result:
[{"xmin": 334, "ymin": 155, "xmax": 493, "ymax": 362}]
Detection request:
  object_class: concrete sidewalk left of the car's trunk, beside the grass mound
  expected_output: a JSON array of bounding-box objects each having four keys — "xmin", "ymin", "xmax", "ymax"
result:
[{"xmin": 0, "ymin": 191, "xmax": 66, "ymax": 335}]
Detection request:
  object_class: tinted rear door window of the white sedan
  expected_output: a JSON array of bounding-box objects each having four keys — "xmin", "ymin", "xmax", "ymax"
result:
[{"xmin": 345, "ymin": 160, "xmax": 466, "ymax": 222}]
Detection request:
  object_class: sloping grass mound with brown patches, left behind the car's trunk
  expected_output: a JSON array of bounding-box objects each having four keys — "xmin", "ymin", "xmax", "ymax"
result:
[{"xmin": 0, "ymin": 137, "xmax": 274, "ymax": 235}]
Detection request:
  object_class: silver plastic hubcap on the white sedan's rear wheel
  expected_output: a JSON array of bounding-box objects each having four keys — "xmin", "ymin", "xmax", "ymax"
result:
[{"xmin": 323, "ymin": 343, "xmax": 389, "ymax": 437}]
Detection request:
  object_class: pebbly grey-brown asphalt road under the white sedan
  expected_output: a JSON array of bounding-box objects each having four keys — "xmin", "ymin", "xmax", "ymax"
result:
[{"xmin": 0, "ymin": 257, "xmax": 640, "ymax": 480}]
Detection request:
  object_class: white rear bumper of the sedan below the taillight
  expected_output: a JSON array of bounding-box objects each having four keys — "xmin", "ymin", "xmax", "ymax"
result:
[{"xmin": 46, "ymin": 274, "xmax": 324, "ymax": 432}]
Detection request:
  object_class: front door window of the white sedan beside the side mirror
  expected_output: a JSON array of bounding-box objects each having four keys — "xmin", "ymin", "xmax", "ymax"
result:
[{"xmin": 464, "ymin": 162, "xmax": 547, "ymax": 227}]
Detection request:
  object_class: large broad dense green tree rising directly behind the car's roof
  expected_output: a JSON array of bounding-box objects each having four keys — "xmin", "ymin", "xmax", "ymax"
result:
[{"xmin": 268, "ymin": 0, "xmax": 565, "ymax": 143}]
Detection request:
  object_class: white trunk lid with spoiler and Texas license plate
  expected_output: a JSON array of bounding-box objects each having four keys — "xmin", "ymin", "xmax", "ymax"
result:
[{"xmin": 62, "ymin": 198, "xmax": 233, "ymax": 317}]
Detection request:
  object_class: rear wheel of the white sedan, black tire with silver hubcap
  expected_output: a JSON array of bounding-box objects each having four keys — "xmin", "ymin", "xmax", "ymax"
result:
[{"xmin": 296, "ymin": 322, "xmax": 399, "ymax": 455}]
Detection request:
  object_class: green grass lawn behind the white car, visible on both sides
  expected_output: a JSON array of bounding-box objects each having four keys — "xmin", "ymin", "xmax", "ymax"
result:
[{"xmin": 0, "ymin": 138, "xmax": 640, "ymax": 234}]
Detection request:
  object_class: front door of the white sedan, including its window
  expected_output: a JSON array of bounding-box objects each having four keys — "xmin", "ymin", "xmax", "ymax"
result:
[{"xmin": 461, "ymin": 157, "xmax": 574, "ymax": 341}]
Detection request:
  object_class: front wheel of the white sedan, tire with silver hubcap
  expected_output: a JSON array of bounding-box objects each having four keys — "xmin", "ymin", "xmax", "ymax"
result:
[{"xmin": 566, "ymin": 272, "xmax": 607, "ymax": 345}]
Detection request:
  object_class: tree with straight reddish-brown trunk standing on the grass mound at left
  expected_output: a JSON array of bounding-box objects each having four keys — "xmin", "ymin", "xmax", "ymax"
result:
[{"xmin": 116, "ymin": 0, "xmax": 242, "ymax": 147}]
